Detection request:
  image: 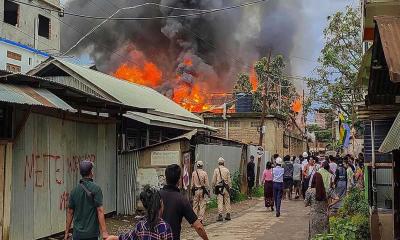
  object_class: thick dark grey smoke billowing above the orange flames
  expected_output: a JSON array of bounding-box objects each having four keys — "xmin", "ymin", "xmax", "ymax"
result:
[{"xmin": 61, "ymin": 0, "xmax": 306, "ymax": 91}]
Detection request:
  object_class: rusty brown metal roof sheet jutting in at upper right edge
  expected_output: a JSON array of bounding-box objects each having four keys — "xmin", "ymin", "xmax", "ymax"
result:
[{"xmin": 375, "ymin": 16, "xmax": 400, "ymax": 82}]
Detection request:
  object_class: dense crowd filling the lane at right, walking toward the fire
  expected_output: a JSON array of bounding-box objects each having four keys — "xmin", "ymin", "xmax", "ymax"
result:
[{"xmin": 256, "ymin": 152, "xmax": 364, "ymax": 239}]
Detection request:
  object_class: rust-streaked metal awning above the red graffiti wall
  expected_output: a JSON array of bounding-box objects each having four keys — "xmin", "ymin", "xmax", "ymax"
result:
[{"xmin": 0, "ymin": 83, "xmax": 75, "ymax": 112}]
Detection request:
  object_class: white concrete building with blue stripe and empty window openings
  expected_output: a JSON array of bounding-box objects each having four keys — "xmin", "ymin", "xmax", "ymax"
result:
[{"xmin": 0, "ymin": 0, "xmax": 61, "ymax": 73}]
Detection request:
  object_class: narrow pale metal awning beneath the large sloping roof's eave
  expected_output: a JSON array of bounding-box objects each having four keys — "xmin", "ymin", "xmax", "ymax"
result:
[{"xmin": 124, "ymin": 112, "xmax": 218, "ymax": 131}]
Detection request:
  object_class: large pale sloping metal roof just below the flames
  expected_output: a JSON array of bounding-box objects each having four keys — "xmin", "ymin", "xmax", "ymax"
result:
[{"xmin": 32, "ymin": 59, "xmax": 202, "ymax": 123}]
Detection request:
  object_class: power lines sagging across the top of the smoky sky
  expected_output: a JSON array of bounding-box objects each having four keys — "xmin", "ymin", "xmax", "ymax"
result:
[{"xmin": 10, "ymin": 0, "xmax": 266, "ymax": 21}]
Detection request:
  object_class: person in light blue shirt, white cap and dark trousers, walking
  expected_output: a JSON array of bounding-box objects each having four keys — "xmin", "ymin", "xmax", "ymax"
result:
[{"xmin": 272, "ymin": 157, "xmax": 284, "ymax": 217}]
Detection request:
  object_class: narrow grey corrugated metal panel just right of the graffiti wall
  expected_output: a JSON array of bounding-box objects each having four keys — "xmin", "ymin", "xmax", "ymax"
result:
[{"xmin": 117, "ymin": 151, "xmax": 139, "ymax": 215}]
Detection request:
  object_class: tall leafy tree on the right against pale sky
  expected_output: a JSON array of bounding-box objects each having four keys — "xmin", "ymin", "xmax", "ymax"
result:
[{"xmin": 306, "ymin": 6, "xmax": 364, "ymax": 119}]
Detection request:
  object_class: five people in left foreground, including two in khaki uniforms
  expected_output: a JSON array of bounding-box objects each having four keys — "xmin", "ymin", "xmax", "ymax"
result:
[{"xmin": 64, "ymin": 157, "xmax": 232, "ymax": 240}]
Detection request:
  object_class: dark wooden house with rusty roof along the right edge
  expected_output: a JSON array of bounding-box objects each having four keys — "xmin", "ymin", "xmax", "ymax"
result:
[{"xmin": 358, "ymin": 16, "xmax": 400, "ymax": 239}]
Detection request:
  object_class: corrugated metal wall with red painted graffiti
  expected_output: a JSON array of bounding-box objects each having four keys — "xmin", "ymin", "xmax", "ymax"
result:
[{"xmin": 10, "ymin": 114, "xmax": 117, "ymax": 240}]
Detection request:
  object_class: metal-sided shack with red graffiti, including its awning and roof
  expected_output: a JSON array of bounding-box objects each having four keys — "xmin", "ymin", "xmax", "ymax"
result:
[{"xmin": 0, "ymin": 68, "xmax": 136, "ymax": 240}]
